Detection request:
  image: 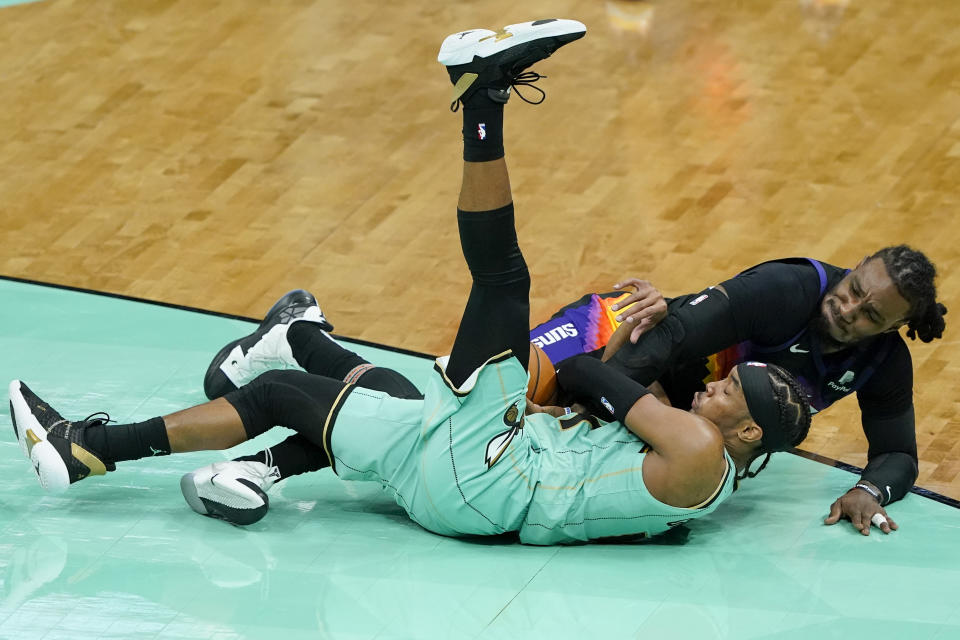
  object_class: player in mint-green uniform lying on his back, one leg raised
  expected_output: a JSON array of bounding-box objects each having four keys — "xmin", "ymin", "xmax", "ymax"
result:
[{"xmin": 10, "ymin": 20, "xmax": 810, "ymax": 544}]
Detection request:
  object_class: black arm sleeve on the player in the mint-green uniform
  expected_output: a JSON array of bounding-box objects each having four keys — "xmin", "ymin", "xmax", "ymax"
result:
[{"xmin": 557, "ymin": 354, "xmax": 650, "ymax": 422}]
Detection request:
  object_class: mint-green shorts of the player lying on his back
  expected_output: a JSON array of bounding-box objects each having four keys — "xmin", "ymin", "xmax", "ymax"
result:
[{"xmin": 324, "ymin": 351, "xmax": 540, "ymax": 535}]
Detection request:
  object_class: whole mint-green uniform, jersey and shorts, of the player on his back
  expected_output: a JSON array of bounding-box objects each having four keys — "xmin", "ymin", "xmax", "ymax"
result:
[{"xmin": 325, "ymin": 352, "xmax": 735, "ymax": 545}]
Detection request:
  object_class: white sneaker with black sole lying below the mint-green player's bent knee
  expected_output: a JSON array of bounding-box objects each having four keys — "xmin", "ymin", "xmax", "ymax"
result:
[{"xmin": 180, "ymin": 460, "xmax": 280, "ymax": 525}]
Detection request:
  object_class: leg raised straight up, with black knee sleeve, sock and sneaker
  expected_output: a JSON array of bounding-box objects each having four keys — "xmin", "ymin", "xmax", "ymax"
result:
[{"xmin": 437, "ymin": 20, "xmax": 586, "ymax": 387}]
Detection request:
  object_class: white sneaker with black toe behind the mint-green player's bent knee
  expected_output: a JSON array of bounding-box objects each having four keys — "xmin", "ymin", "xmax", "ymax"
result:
[{"xmin": 203, "ymin": 289, "xmax": 333, "ymax": 400}]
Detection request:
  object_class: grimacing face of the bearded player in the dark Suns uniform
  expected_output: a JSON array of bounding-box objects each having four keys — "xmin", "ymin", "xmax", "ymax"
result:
[{"xmin": 817, "ymin": 259, "xmax": 910, "ymax": 346}]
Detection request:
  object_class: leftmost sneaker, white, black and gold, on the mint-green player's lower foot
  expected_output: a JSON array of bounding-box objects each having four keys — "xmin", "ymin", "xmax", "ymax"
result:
[{"xmin": 9, "ymin": 380, "xmax": 116, "ymax": 491}]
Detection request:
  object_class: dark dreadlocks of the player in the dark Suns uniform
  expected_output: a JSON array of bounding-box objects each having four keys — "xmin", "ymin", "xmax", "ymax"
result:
[{"xmin": 870, "ymin": 244, "xmax": 947, "ymax": 342}]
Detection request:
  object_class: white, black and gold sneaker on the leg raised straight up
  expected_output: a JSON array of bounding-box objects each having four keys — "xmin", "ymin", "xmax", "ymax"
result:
[{"xmin": 437, "ymin": 18, "xmax": 587, "ymax": 111}]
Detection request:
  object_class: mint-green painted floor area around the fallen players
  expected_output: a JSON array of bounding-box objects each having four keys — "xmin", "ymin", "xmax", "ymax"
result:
[{"xmin": 0, "ymin": 280, "xmax": 960, "ymax": 640}]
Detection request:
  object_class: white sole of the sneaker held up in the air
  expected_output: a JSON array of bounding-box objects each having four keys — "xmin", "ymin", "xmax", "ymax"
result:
[{"xmin": 437, "ymin": 19, "xmax": 587, "ymax": 67}]
